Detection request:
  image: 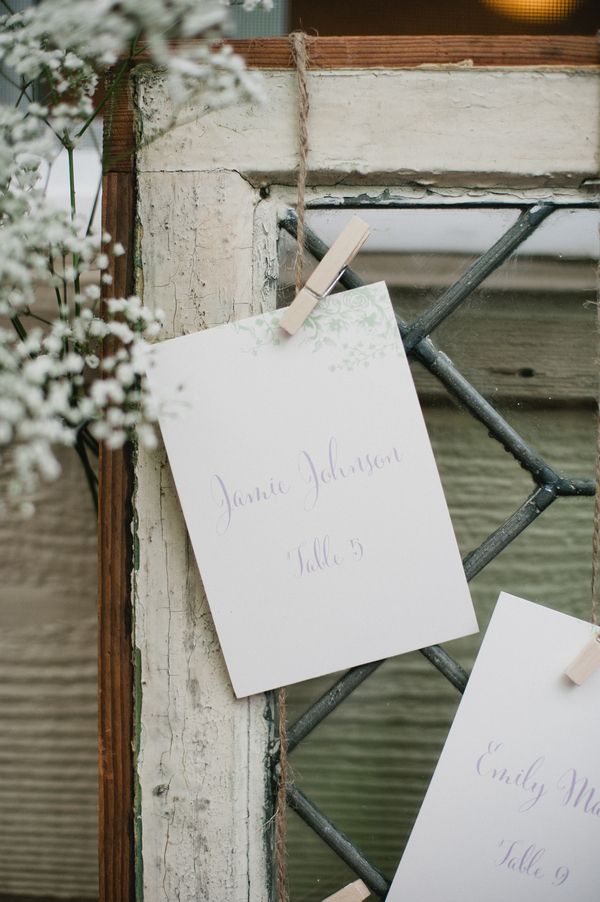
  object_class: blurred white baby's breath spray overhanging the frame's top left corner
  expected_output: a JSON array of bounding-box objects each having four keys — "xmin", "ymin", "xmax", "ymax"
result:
[{"xmin": 0, "ymin": 0, "xmax": 272, "ymax": 123}]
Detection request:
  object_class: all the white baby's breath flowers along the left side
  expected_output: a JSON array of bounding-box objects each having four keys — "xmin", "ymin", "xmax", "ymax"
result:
[{"xmin": 0, "ymin": 0, "xmax": 271, "ymax": 514}]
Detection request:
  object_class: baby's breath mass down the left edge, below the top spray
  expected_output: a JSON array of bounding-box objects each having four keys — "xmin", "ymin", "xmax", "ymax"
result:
[{"xmin": 0, "ymin": 107, "xmax": 161, "ymax": 512}]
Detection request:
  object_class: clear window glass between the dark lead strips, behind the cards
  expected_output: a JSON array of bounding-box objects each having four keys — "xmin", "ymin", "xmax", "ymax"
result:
[{"xmin": 280, "ymin": 206, "xmax": 598, "ymax": 902}]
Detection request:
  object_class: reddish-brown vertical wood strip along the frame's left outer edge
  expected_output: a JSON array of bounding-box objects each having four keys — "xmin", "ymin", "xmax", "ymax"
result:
[{"xmin": 98, "ymin": 166, "xmax": 135, "ymax": 902}]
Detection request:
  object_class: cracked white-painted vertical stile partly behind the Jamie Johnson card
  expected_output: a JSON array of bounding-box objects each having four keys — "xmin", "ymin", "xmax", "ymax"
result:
[{"xmin": 134, "ymin": 172, "xmax": 272, "ymax": 902}]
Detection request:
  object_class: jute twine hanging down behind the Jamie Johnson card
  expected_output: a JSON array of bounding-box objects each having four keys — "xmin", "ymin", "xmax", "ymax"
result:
[{"xmin": 275, "ymin": 31, "xmax": 309, "ymax": 902}]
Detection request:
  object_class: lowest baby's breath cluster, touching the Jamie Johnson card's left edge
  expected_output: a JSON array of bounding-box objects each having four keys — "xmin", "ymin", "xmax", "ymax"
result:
[{"xmin": 0, "ymin": 245, "xmax": 162, "ymax": 513}]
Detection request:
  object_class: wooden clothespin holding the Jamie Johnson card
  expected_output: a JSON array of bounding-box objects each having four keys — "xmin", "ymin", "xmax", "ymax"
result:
[{"xmin": 279, "ymin": 216, "xmax": 369, "ymax": 335}]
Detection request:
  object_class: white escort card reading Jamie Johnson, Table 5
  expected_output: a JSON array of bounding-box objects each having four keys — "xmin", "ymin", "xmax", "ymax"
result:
[{"xmin": 143, "ymin": 283, "xmax": 477, "ymax": 696}]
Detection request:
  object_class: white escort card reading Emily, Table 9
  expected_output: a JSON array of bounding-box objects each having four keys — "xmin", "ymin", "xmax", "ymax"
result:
[{"xmin": 387, "ymin": 593, "xmax": 600, "ymax": 902}]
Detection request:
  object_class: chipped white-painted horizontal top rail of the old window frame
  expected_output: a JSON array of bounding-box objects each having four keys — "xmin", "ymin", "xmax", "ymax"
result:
[{"xmin": 139, "ymin": 68, "xmax": 600, "ymax": 186}]
